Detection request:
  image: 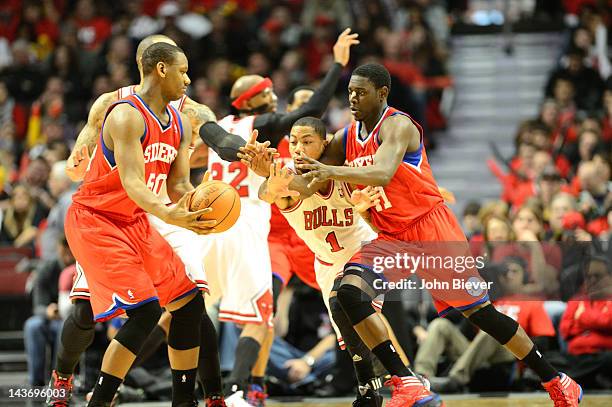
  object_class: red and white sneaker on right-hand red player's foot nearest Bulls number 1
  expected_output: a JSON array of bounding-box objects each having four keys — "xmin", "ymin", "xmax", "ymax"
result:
[{"xmin": 385, "ymin": 376, "xmax": 444, "ymax": 407}]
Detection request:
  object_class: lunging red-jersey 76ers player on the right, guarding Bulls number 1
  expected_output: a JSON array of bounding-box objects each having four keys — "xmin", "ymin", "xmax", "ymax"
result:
[{"xmin": 291, "ymin": 64, "xmax": 582, "ymax": 407}]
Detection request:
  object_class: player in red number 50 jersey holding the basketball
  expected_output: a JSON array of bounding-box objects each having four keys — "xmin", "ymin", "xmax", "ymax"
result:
[{"xmin": 65, "ymin": 43, "xmax": 216, "ymax": 406}]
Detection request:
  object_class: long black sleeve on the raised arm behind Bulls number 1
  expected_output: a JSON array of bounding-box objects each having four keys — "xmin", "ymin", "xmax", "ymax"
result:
[{"xmin": 253, "ymin": 63, "xmax": 342, "ymax": 147}]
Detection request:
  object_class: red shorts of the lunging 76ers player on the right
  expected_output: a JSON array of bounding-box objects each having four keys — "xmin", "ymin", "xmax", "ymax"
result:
[{"xmin": 347, "ymin": 205, "xmax": 489, "ymax": 316}]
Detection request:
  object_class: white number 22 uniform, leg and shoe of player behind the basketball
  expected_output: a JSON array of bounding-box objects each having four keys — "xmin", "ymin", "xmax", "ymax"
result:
[{"xmin": 204, "ymin": 112, "xmax": 274, "ymax": 405}]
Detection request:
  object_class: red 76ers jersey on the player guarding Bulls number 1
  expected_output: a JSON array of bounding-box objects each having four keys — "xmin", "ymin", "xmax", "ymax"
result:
[{"xmin": 344, "ymin": 107, "xmax": 444, "ymax": 234}]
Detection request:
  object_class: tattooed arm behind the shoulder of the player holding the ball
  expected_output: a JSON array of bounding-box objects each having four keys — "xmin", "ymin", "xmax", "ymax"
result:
[{"xmin": 66, "ymin": 92, "xmax": 117, "ymax": 182}]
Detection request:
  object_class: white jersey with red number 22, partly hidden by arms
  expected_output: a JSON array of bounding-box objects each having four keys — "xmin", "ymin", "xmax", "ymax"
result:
[{"xmin": 208, "ymin": 115, "xmax": 271, "ymax": 228}]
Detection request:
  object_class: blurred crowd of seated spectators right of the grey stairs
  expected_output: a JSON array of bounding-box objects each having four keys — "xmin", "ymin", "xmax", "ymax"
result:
[{"xmin": 452, "ymin": 1, "xmax": 612, "ymax": 391}]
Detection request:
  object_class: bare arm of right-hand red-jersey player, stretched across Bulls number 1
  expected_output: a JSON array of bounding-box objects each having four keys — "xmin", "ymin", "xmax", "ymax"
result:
[{"xmin": 298, "ymin": 115, "xmax": 421, "ymax": 186}]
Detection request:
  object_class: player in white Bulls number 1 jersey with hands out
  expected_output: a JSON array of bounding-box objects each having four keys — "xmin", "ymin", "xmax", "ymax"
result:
[{"xmin": 253, "ymin": 117, "xmax": 401, "ymax": 407}]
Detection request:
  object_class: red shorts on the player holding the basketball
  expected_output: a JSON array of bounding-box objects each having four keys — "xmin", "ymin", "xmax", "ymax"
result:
[{"xmin": 65, "ymin": 204, "xmax": 197, "ymax": 321}]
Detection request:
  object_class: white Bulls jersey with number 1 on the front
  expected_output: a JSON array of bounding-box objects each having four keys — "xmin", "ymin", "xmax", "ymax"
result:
[{"xmin": 281, "ymin": 180, "xmax": 376, "ymax": 265}]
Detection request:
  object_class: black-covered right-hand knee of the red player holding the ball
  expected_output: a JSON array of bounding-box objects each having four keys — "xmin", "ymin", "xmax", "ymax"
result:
[{"xmin": 168, "ymin": 295, "xmax": 205, "ymax": 350}]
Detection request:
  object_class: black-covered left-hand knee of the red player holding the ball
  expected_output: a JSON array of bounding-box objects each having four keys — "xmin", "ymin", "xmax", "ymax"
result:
[{"xmin": 114, "ymin": 301, "xmax": 162, "ymax": 355}]
